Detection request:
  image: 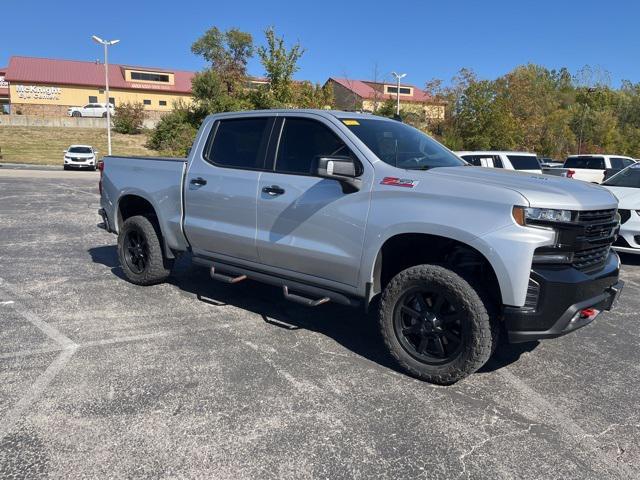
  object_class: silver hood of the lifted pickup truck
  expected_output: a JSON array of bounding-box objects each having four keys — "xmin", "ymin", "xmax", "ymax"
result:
[{"xmin": 428, "ymin": 167, "xmax": 617, "ymax": 210}]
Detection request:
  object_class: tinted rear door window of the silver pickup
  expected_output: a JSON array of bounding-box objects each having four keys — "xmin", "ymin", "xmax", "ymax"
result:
[{"xmin": 204, "ymin": 117, "xmax": 269, "ymax": 169}]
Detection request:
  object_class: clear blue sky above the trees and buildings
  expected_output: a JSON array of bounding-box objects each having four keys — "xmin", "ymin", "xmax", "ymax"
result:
[{"xmin": 0, "ymin": 0, "xmax": 640, "ymax": 86}]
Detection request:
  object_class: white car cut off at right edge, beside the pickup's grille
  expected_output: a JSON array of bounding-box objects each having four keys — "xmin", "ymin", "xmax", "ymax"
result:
[{"xmin": 602, "ymin": 163, "xmax": 640, "ymax": 254}]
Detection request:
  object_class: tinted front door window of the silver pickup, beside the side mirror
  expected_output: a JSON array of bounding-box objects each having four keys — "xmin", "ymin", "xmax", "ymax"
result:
[{"xmin": 276, "ymin": 118, "xmax": 351, "ymax": 174}]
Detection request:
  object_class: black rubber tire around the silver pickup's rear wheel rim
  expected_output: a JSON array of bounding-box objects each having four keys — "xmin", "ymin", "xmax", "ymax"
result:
[{"xmin": 118, "ymin": 215, "xmax": 172, "ymax": 285}]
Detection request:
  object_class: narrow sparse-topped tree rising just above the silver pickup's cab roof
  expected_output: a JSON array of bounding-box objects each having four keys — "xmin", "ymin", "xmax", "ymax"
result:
[{"xmin": 258, "ymin": 27, "xmax": 304, "ymax": 106}]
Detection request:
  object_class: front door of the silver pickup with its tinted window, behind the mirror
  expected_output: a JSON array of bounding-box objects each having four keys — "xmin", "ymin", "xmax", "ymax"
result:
[{"xmin": 252, "ymin": 115, "xmax": 373, "ymax": 286}]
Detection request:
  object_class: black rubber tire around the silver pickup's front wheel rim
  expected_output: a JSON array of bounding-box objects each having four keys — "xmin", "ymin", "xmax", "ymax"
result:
[{"xmin": 379, "ymin": 265, "xmax": 498, "ymax": 385}]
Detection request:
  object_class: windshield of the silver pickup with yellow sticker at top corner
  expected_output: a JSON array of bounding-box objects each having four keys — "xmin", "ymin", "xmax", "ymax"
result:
[{"xmin": 342, "ymin": 118, "xmax": 466, "ymax": 170}]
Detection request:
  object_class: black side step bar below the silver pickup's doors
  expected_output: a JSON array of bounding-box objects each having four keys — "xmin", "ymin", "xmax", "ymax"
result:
[{"xmin": 193, "ymin": 257, "xmax": 361, "ymax": 307}]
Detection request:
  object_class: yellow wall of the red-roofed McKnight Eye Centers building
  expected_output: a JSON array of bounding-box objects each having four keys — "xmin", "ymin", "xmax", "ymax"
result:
[{"xmin": 9, "ymin": 83, "xmax": 191, "ymax": 112}]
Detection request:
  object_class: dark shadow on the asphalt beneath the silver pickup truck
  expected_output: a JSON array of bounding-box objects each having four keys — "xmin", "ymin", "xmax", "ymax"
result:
[{"xmin": 88, "ymin": 245, "xmax": 537, "ymax": 373}]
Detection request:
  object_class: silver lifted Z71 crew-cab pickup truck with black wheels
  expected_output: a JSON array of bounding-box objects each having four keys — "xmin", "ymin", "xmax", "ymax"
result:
[{"xmin": 99, "ymin": 110, "xmax": 622, "ymax": 384}]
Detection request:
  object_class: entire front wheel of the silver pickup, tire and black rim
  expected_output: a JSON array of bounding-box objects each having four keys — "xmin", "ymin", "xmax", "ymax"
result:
[{"xmin": 379, "ymin": 265, "xmax": 497, "ymax": 385}]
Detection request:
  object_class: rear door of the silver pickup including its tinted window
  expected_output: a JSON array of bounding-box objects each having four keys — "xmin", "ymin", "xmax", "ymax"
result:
[{"xmin": 184, "ymin": 115, "xmax": 274, "ymax": 261}]
